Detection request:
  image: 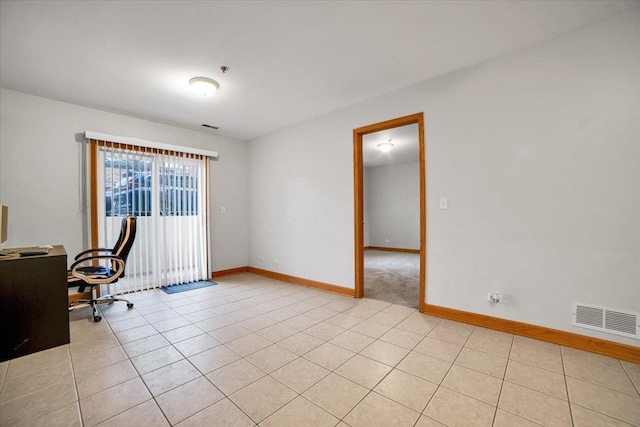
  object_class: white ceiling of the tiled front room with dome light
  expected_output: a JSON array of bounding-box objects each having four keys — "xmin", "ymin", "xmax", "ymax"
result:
[{"xmin": 0, "ymin": 0, "xmax": 639, "ymax": 139}]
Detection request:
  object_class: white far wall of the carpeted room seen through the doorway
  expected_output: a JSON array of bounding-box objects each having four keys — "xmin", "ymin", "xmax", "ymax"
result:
[{"xmin": 364, "ymin": 162, "xmax": 420, "ymax": 249}]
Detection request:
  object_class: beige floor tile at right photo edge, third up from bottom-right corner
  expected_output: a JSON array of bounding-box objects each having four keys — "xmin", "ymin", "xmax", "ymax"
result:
[{"xmin": 562, "ymin": 355, "xmax": 638, "ymax": 397}]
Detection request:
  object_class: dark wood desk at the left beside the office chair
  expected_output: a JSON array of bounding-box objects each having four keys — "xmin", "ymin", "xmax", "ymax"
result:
[{"xmin": 0, "ymin": 245, "xmax": 69, "ymax": 362}]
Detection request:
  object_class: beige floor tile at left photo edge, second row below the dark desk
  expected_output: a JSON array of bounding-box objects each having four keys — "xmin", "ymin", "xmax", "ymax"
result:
[{"xmin": 0, "ymin": 360, "xmax": 73, "ymax": 403}]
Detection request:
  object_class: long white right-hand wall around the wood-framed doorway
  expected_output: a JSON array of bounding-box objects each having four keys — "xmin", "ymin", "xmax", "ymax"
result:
[{"xmin": 249, "ymin": 10, "xmax": 640, "ymax": 345}]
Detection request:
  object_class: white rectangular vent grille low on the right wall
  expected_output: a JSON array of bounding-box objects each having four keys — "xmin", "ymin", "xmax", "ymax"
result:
[{"xmin": 571, "ymin": 302, "xmax": 640, "ymax": 339}]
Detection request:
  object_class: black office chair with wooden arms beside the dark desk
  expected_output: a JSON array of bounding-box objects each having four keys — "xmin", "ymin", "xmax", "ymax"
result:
[{"xmin": 67, "ymin": 215, "xmax": 136, "ymax": 322}]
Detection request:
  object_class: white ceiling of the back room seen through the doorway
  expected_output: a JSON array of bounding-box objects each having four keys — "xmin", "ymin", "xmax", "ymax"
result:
[{"xmin": 362, "ymin": 124, "xmax": 420, "ymax": 168}]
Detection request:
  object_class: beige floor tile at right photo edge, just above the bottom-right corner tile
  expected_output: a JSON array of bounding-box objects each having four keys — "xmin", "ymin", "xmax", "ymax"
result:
[{"xmin": 567, "ymin": 377, "xmax": 640, "ymax": 425}]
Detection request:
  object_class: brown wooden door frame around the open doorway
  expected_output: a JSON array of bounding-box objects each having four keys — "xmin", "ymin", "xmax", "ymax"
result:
[{"xmin": 353, "ymin": 113, "xmax": 427, "ymax": 312}]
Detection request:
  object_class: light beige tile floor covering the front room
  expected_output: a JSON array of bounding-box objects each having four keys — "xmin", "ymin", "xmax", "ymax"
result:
[{"xmin": 0, "ymin": 274, "xmax": 640, "ymax": 427}]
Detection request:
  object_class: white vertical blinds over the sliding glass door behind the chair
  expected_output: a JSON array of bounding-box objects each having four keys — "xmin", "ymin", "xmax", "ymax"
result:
[{"xmin": 89, "ymin": 139, "xmax": 209, "ymax": 293}]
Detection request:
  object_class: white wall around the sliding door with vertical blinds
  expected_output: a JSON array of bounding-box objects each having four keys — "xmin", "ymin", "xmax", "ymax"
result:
[{"xmin": 0, "ymin": 89, "xmax": 248, "ymax": 271}]
